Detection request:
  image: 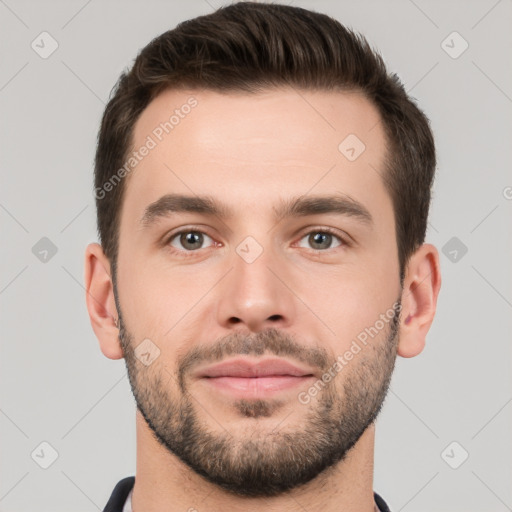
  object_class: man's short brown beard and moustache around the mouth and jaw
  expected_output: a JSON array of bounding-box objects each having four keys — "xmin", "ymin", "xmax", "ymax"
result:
[{"xmin": 116, "ymin": 290, "xmax": 400, "ymax": 497}]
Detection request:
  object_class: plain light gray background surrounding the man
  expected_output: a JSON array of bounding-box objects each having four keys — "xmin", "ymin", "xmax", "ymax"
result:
[{"xmin": 0, "ymin": 0, "xmax": 512, "ymax": 512}]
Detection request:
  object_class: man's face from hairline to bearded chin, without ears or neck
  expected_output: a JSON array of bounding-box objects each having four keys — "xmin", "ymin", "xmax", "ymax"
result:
[{"xmin": 114, "ymin": 89, "xmax": 401, "ymax": 496}]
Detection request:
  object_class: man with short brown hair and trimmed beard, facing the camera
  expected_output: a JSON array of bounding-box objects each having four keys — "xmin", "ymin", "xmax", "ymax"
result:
[{"xmin": 85, "ymin": 3, "xmax": 441, "ymax": 512}]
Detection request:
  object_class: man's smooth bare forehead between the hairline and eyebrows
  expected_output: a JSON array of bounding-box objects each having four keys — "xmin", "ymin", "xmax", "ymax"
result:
[{"xmin": 123, "ymin": 88, "xmax": 390, "ymax": 228}]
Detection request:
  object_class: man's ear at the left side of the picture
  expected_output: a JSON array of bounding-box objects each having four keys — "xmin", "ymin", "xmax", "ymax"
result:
[{"xmin": 85, "ymin": 243, "xmax": 123, "ymax": 359}]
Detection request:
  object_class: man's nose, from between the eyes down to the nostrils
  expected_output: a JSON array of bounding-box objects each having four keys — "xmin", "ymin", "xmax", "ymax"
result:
[{"xmin": 217, "ymin": 243, "xmax": 296, "ymax": 332}]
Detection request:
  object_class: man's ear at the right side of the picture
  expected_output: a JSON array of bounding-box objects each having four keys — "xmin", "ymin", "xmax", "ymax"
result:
[{"xmin": 397, "ymin": 244, "xmax": 441, "ymax": 357}]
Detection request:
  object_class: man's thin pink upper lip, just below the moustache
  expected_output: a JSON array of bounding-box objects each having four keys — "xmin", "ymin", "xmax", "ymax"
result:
[{"xmin": 196, "ymin": 358, "xmax": 314, "ymax": 379}]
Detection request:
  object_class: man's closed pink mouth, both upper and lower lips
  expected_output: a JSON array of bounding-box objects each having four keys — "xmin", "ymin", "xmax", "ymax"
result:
[{"xmin": 191, "ymin": 358, "xmax": 315, "ymax": 398}]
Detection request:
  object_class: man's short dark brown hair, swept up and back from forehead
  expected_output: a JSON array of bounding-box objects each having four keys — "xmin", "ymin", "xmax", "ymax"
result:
[{"xmin": 95, "ymin": 2, "xmax": 436, "ymax": 283}]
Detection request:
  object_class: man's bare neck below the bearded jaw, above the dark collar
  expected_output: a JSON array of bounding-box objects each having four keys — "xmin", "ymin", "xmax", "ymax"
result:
[{"xmin": 132, "ymin": 411, "xmax": 375, "ymax": 512}]
